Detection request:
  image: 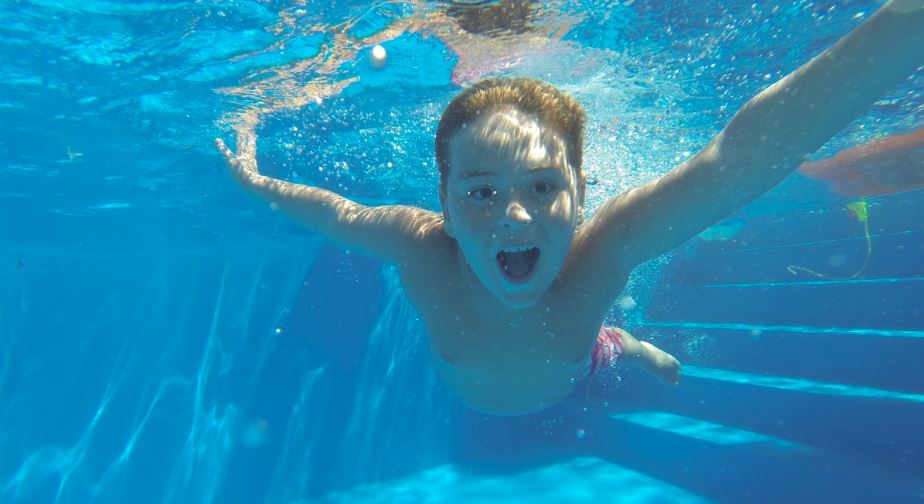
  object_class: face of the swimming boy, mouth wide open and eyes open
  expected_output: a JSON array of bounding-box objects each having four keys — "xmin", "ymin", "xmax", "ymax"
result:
[{"xmin": 441, "ymin": 110, "xmax": 580, "ymax": 308}]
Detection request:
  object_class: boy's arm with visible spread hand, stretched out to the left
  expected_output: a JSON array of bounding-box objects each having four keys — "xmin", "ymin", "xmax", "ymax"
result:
[{"xmin": 215, "ymin": 129, "xmax": 442, "ymax": 265}]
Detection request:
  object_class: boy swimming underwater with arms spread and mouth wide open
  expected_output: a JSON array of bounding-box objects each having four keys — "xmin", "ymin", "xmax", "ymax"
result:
[{"xmin": 216, "ymin": 0, "xmax": 924, "ymax": 415}]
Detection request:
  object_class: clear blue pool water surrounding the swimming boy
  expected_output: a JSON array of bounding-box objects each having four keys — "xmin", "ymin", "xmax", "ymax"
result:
[{"xmin": 0, "ymin": 0, "xmax": 924, "ymax": 504}]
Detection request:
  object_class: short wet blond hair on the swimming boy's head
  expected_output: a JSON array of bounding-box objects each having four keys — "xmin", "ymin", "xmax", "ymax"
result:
[{"xmin": 436, "ymin": 77, "xmax": 585, "ymax": 204}]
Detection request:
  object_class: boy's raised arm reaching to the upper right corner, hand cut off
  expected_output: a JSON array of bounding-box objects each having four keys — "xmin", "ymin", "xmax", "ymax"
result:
[{"xmin": 579, "ymin": 0, "xmax": 924, "ymax": 277}]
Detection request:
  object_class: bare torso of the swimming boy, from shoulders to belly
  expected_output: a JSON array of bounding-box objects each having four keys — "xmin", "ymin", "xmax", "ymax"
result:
[{"xmin": 401, "ymin": 222, "xmax": 625, "ymax": 415}]
